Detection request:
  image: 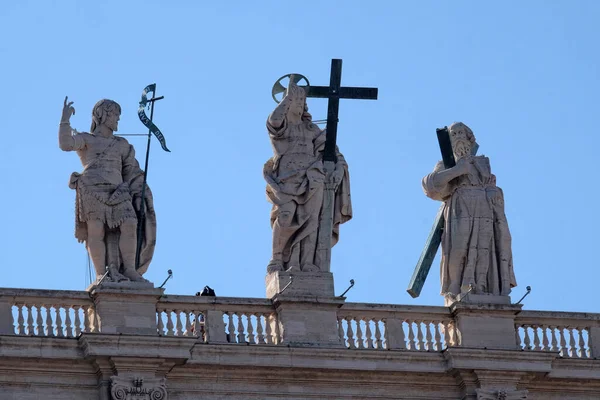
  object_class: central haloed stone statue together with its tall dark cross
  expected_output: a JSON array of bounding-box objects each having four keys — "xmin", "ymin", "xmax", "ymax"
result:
[{"xmin": 263, "ymin": 60, "xmax": 377, "ymax": 273}]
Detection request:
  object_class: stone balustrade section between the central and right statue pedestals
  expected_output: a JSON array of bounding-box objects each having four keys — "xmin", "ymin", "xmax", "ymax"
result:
[{"xmin": 338, "ymin": 303, "xmax": 459, "ymax": 351}]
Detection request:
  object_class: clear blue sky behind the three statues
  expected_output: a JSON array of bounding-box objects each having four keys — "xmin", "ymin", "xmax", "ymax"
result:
[{"xmin": 0, "ymin": 0, "xmax": 600, "ymax": 312}]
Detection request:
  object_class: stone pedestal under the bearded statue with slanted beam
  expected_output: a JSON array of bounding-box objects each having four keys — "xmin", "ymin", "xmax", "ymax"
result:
[{"xmin": 450, "ymin": 296, "xmax": 522, "ymax": 350}]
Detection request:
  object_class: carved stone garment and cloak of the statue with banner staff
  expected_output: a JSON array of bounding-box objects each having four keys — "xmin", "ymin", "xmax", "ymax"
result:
[{"xmin": 69, "ymin": 133, "xmax": 156, "ymax": 274}]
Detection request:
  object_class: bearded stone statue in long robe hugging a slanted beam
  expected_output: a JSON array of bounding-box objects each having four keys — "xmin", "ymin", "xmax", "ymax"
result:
[{"xmin": 423, "ymin": 122, "xmax": 517, "ymax": 299}]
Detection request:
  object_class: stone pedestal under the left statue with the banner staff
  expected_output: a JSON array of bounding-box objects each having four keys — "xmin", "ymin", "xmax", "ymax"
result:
[{"xmin": 88, "ymin": 282, "xmax": 164, "ymax": 335}]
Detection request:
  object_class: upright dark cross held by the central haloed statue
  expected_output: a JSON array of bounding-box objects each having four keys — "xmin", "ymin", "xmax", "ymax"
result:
[{"xmin": 307, "ymin": 58, "xmax": 377, "ymax": 162}]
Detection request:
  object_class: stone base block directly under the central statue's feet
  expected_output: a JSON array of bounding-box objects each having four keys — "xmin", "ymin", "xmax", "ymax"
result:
[{"xmin": 265, "ymin": 271, "xmax": 335, "ymax": 299}]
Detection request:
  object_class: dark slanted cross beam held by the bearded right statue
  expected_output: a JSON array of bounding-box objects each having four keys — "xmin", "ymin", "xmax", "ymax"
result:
[{"xmin": 406, "ymin": 127, "xmax": 479, "ymax": 298}]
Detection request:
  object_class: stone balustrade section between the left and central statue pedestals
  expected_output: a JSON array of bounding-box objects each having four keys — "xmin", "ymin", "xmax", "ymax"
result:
[{"xmin": 156, "ymin": 295, "xmax": 281, "ymax": 345}]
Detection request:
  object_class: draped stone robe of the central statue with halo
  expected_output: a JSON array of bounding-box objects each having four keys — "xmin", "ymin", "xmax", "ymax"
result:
[{"xmin": 263, "ymin": 118, "xmax": 352, "ymax": 268}]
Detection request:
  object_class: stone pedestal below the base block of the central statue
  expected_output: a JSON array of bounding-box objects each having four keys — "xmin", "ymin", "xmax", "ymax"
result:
[{"xmin": 273, "ymin": 290, "xmax": 345, "ymax": 348}]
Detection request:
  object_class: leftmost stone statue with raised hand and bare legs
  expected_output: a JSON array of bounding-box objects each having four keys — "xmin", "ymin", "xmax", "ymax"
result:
[{"xmin": 58, "ymin": 98, "xmax": 156, "ymax": 282}]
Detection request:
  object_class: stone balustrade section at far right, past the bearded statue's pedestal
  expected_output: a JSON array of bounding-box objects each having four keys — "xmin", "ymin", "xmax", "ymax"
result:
[{"xmin": 515, "ymin": 311, "xmax": 600, "ymax": 358}]
